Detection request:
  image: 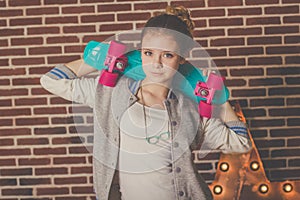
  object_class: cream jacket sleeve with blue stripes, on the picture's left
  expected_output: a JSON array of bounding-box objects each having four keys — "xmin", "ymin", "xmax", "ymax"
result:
[{"xmin": 40, "ymin": 64, "xmax": 98, "ymax": 108}]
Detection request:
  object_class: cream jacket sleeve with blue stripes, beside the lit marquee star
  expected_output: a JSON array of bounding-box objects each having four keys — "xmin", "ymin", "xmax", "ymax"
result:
[{"xmin": 201, "ymin": 118, "xmax": 252, "ymax": 153}]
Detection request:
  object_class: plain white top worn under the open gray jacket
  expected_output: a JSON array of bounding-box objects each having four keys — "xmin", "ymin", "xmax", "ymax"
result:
[{"xmin": 119, "ymin": 102, "xmax": 175, "ymax": 200}]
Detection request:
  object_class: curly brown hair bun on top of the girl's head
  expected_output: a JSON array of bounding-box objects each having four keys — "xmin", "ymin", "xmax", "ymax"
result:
[{"xmin": 161, "ymin": 6, "xmax": 195, "ymax": 33}]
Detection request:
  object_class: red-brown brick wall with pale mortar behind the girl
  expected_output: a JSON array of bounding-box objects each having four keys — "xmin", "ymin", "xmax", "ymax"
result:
[{"xmin": 0, "ymin": 0, "xmax": 300, "ymax": 200}]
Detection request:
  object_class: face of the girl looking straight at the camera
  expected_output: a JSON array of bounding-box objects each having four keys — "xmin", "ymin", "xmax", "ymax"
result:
[{"xmin": 141, "ymin": 33, "xmax": 184, "ymax": 84}]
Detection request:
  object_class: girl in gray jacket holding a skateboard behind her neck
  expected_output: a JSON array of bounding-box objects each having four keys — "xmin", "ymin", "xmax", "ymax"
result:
[{"xmin": 41, "ymin": 7, "xmax": 251, "ymax": 200}]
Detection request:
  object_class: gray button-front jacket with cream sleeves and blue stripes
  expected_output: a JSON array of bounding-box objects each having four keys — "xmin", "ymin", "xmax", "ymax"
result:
[{"xmin": 41, "ymin": 65, "xmax": 251, "ymax": 200}]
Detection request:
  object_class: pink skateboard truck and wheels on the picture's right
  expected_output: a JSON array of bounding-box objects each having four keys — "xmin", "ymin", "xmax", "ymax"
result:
[{"xmin": 194, "ymin": 73, "xmax": 225, "ymax": 118}]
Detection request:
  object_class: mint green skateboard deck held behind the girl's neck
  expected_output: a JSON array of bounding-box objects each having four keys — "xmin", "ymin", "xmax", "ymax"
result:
[{"xmin": 83, "ymin": 41, "xmax": 229, "ymax": 104}]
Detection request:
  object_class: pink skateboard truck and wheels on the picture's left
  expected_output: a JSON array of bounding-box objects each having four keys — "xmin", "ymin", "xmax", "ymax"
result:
[{"xmin": 99, "ymin": 40, "xmax": 128, "ymax": 87}]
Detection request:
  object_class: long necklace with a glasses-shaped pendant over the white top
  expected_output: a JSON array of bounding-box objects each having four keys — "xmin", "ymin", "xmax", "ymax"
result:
[{"xmin": 141, "ymin": 86, "xmax": 171, "ymax": 144}]
